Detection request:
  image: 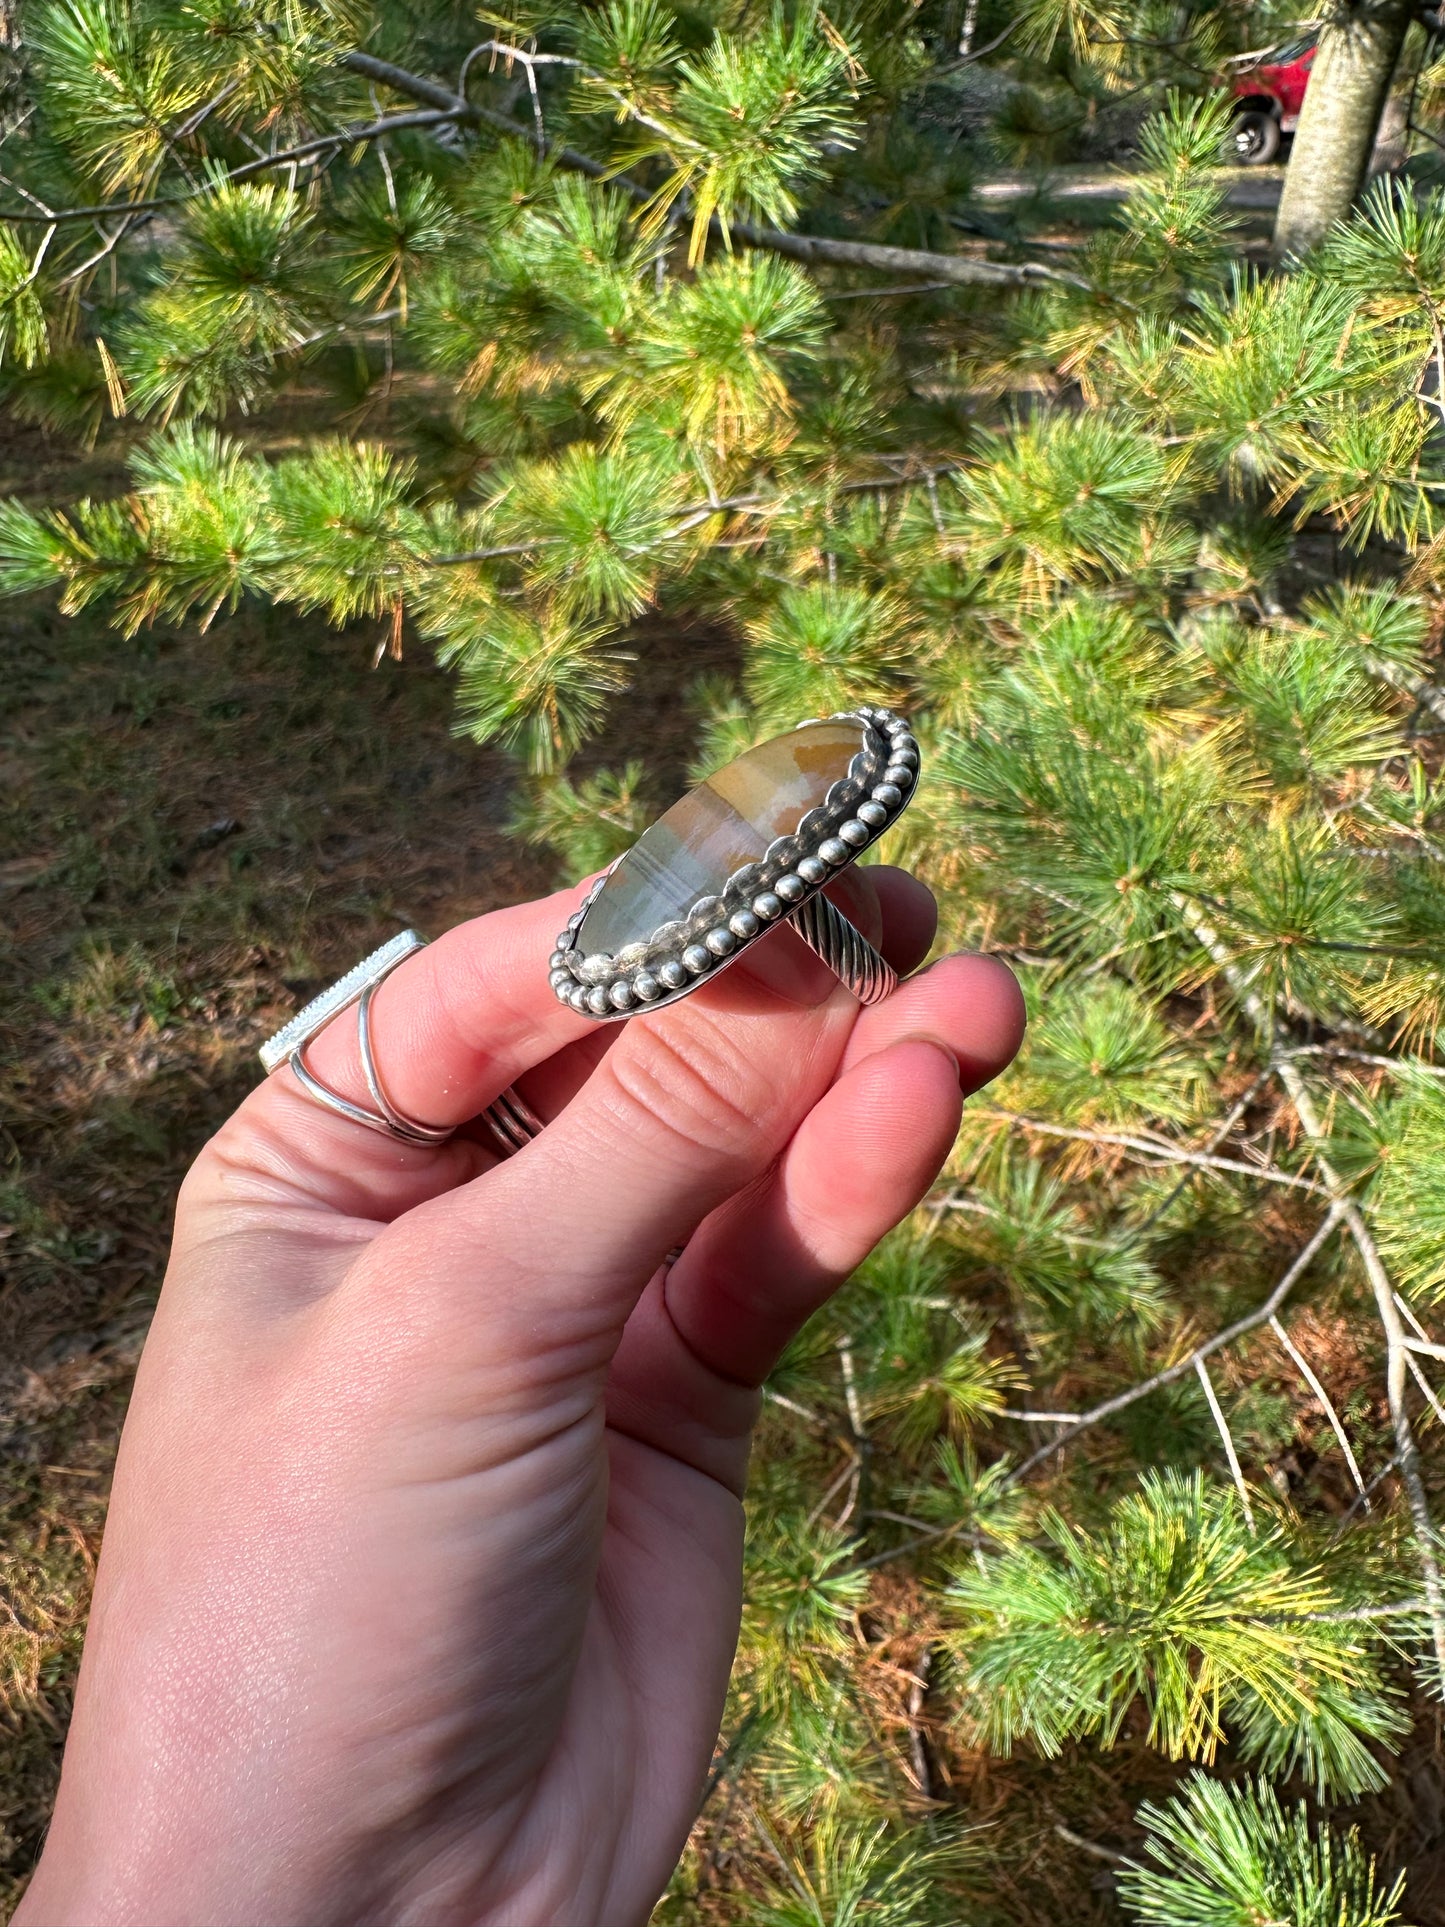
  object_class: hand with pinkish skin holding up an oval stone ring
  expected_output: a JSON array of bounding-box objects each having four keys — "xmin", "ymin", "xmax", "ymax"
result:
[{"xmin": 17, "ymin": 869, "xmax": 1023, "ymax": 1927}]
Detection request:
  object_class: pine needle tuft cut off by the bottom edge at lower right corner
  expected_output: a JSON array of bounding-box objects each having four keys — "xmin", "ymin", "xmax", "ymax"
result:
[{"xmin": 1121, "ymin": 1775, "xmax": 1405, "ymax": 1927}]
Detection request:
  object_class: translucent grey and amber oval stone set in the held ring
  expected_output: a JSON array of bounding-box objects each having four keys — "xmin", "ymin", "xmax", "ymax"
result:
[{"xmin": 578, "ymin": 723, "xmax": 863, "ymax": 956}]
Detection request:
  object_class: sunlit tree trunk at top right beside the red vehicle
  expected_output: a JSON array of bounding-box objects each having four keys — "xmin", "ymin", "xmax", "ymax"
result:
[{"xmin": 1274, "ymin": 0, "xmax": 1414, "ymax": 260}]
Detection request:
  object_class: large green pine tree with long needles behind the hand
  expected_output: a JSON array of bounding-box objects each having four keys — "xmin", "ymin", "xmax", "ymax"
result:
[{"xmin": 0, "ymin": 0, "xmax": 1445, "ymax": 1927}]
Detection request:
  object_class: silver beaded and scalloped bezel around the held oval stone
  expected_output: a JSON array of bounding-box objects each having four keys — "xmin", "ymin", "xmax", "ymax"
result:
[{"xmin": 549, "ymin": 707, "xmax": 919, "ymax": 1023}]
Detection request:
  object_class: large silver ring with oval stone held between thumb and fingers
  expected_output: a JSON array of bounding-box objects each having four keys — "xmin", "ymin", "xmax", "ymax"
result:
[{"xmin": 547, "ymin": 709, "xmax": 919, "ymax": 1023}]
